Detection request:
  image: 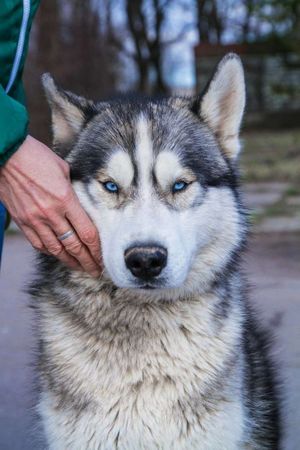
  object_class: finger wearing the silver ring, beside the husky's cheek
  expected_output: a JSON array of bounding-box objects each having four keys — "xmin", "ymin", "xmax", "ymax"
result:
[{"xmin": 58, "ymin": 225, "xmax": 100, "ymax": 277}]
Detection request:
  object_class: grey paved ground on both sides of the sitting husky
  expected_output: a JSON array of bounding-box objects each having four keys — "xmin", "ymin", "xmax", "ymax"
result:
[{"xmin": 0, "ymin": 233, "xmax": 300, "ymax": 450}]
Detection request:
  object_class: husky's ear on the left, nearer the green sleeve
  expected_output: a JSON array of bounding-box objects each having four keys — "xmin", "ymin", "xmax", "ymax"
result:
[{"xmin": 42, "ymin": 73, "xmax": 97, "ymax": 157}]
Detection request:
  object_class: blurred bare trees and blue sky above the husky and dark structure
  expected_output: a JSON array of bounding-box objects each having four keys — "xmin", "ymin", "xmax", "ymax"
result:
[{"xmin": 27, "ymin": 0, "xmax": 300, "ymax": 102}]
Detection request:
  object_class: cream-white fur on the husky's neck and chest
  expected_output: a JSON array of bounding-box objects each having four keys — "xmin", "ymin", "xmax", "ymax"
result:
[{"xmin": 38, "ymin": 262, "xmax": 246, "ymax": 449}]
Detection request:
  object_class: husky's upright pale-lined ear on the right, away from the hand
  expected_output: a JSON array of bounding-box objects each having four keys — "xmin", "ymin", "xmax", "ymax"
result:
[{"xmin": 198, "ymin": 53, "xmax": 246, "ymax": 159}]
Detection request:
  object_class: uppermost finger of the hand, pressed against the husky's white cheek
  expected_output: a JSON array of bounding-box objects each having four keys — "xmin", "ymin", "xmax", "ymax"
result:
[{"xmin": 66, "ymin": 195, "xmax": 102, "ymax": 266}]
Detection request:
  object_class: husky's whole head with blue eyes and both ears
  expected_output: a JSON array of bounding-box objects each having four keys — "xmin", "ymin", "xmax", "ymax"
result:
[{"xmin": 44, "ymin": 55, "xmax": 245, "ymax": 290}]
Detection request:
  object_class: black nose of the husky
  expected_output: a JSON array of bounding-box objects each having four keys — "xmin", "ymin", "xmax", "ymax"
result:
[{"xmin": 124, "ymin": 245, "xmax": 168, "ymax": 280}]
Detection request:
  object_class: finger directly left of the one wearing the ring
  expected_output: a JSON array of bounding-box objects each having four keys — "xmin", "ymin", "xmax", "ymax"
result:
[{"xmin": 36, "ymin": 224, "xmax": 83, "ymax": 270}]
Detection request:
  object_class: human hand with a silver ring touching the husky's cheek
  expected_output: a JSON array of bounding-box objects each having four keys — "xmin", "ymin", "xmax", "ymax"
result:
[{"xmin": 0, "ymin": 136, "xmax": 101, "ymax": 277}]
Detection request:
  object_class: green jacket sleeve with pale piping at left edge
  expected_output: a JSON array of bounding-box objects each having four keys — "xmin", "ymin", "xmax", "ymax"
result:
[{"xmin": 0, "ymin": 0, "xmax": 40, "ymax": 166}]
